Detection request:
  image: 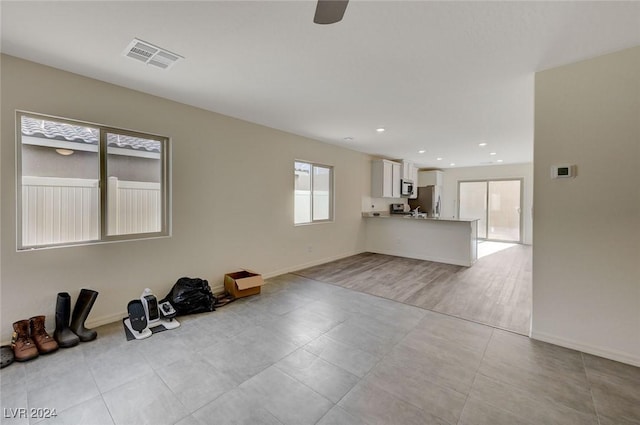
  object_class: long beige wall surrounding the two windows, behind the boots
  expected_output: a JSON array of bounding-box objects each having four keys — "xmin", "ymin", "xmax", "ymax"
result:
[{"xmin": 0, "ymin": 56, "xmax": 370, "ymax": 342}]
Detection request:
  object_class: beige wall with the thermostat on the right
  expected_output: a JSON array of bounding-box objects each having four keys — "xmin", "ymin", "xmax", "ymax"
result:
[{"xmin": 531, "ymin": 47, "xmax": 640, "ymax": 366}]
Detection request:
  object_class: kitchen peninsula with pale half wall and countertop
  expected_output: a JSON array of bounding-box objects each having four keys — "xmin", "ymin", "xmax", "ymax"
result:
[{"xmin": 362, "ymin": 212, "xmax": 478, "ymax": 267}]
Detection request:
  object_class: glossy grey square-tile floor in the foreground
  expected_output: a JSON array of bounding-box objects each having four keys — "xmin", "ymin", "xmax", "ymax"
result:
[{"xmin": 0, "ymin": 274, "xmax": 640, "ymax": 425}]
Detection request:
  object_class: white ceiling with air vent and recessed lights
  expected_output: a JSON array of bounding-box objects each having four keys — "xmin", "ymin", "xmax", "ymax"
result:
[{"xmin": 0, "ymin": 0, "xmax": 640, "ymax": 168}]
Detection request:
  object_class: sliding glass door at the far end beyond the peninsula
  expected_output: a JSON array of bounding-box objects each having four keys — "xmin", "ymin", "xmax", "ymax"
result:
[{"xmin": 458, "ymin": 179, "xmax": 522, "ymax": 242}]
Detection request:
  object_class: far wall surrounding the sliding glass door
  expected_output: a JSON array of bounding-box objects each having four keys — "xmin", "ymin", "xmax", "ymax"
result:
[{"xmin": 441, "ymin": 163, "xmax": 533, "ymax": 245}]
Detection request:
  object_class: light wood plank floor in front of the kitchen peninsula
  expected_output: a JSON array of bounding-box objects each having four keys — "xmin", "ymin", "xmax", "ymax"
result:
[{"xmin": 294, "ymin": 245, "xmax": 531, "ymax": 335}]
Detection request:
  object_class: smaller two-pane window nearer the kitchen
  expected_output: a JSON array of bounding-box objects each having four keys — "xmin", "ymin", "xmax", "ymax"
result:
[{"xmin": 294, "ymin": 161, "xmax": 333, "ymax": 224}]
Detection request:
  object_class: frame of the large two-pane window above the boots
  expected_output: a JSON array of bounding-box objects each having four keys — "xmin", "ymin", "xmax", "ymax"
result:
[{"xmin": 16, "ymin": 110, "xmax": 171, "ymax": 251}]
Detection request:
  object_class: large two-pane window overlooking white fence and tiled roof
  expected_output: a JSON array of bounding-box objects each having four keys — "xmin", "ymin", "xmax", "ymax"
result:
[{"xmin": 17, "ymin": 112, "xmax": 170, "ymax": 249}]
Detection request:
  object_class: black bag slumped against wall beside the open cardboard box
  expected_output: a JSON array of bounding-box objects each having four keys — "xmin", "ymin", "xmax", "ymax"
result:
[{"xmin": 162, "ymin": 277, "xmax": 217, "ymax": 316}]
